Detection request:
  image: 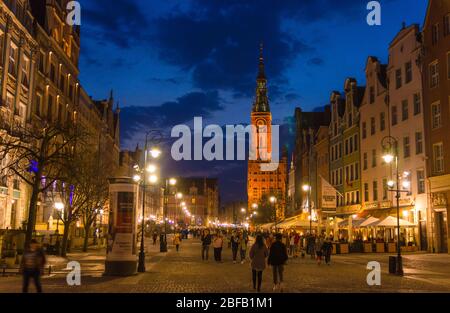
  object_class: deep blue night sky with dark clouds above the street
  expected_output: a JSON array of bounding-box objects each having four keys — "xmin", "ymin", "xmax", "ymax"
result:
[{"xmin": 76, "ymin": 0, "xmax": 427, "ymax": 202}]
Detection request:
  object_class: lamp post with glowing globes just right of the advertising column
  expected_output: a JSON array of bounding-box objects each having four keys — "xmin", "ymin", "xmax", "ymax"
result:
[{"xmin": 138, "ymin": 130, "xmax": 161, "ymax": 273}]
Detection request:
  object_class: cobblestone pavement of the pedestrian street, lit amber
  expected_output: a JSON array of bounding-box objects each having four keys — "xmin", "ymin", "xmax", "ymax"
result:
[{"xmin": 0, "ymin": 239, "xmax": 450, "ymax": 293}]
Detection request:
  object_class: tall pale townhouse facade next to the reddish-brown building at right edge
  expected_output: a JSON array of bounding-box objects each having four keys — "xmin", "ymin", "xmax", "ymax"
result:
[{"xmin": 386, "ymin": 25, "xmax": 431, "ymax": 250}]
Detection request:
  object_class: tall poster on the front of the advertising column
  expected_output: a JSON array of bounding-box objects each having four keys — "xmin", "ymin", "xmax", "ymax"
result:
[{"xmin": 111, "ymin": 192, "xmax": 134, "ymax": 258}]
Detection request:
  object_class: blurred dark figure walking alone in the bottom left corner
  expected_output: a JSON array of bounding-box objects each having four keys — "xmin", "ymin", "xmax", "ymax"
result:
[{"xmin": 20, "ymin": 239, "xmax": 46, "ymax": 293}]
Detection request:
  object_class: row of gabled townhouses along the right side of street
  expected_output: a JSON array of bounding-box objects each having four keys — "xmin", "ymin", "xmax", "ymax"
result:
[{"xmin": 285, "ymin": 0, "xmax": 450, "ymax": 252}]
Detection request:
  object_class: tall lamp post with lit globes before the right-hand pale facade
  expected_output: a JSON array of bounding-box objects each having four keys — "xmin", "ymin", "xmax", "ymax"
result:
[{"xmin": 381, "ymin": 136, "xmax": 408, "ymax": 276}]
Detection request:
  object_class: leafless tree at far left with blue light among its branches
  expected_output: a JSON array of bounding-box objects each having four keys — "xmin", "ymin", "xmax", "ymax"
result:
[{"xmin": 0, "ymin": 121, "xmax": 83, "ymax": 246}]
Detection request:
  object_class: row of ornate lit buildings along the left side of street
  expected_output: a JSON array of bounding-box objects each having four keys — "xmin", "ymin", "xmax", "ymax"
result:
[{"xmin": 0, "ymin": 0, "xmax": 120, "ymax": 243}]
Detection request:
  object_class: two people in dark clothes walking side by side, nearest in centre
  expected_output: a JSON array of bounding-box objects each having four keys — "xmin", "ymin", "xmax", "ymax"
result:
[{"xmin": 250, "ymin": 234, "xmax": 288, "ymax": 292}]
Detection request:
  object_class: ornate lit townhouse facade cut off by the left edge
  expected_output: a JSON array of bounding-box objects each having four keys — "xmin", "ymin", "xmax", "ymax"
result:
[{"xmin": 0, "ymin": 1, "xmax": 38, "ymax": 229}]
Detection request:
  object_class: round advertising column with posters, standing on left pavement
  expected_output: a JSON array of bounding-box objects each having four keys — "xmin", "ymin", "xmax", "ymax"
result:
[{"xmin": 105, "ymin": 177, "xmax": 138, "ymax": 276}]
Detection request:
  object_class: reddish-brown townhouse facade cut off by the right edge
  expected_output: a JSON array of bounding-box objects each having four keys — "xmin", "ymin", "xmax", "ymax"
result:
[{"xmin": 421, "ymin": 0, "xmax": 450, "ymax": 252}]
